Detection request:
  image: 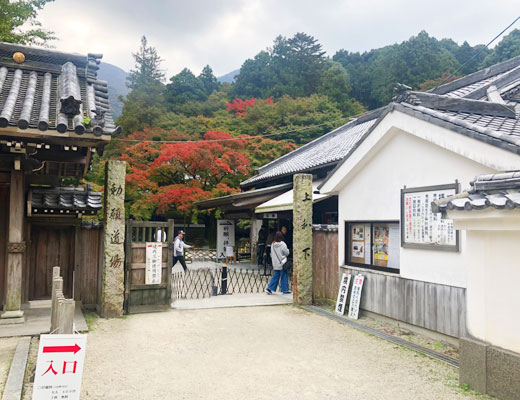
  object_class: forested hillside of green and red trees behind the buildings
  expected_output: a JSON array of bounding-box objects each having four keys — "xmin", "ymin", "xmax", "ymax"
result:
[{"xmin": 87, "ymin": 31, "xmax": 520, "ymax": 221}]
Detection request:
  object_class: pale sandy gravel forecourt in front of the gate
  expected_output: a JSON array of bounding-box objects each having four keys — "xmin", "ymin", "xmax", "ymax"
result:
[{"xmin": 82, "ymin": 306, "xmax": 476, "ymax": 400}]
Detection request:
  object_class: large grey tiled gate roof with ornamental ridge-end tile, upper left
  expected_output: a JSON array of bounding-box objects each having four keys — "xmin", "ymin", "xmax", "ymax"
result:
[{"xmin": 0, "ymin": 43, "xmax": 121, "ymax": 136}]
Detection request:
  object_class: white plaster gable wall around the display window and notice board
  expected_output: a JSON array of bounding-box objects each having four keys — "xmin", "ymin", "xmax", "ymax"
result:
[{"xmin": 338, "ymin": 127, "xmax": 496, "ymax": 287}]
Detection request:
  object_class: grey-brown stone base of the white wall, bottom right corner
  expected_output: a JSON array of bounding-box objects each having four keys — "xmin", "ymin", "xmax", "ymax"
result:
[{"xmin": 459, "ymin": 338, "xmax": 520, "ymax": 400}]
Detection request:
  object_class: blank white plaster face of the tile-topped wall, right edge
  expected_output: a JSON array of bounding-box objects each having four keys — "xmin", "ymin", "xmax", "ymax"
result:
[{"xmin": 466, "ymin": 226, "xmax": 520, "ymax": 353}]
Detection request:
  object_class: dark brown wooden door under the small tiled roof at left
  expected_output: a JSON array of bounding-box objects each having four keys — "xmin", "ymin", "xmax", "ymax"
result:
[{"xmin": 29, "ymin": 225, "xmax": 74, "ymax": 300}]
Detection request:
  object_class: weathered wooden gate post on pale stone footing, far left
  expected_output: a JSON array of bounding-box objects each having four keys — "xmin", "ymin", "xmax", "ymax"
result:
[{"xmin": 0, "ymin": 170, "xmax": 26, "ymax": 324}]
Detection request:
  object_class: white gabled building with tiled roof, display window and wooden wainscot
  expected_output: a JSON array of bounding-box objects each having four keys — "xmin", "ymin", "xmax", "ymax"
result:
[{"xmin": 319, "ymin": 57, "xmax": 520, "ymax": 338}]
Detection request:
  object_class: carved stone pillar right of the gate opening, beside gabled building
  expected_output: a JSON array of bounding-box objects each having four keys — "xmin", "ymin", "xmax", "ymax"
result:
[{"xmin": 293, "ymin": 174, "xmax": 312, "ymax": 305}]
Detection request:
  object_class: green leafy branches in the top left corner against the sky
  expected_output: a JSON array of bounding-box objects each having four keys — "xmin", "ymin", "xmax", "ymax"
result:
[{"xmin": 0, "ymin": 0, "xmax": 56, "ymax": 45}]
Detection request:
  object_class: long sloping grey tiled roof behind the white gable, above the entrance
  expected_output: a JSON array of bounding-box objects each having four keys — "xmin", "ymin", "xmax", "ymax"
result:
[{"xmin": 241, "ymin": 110, "xmax": 380, "ymax": 187}]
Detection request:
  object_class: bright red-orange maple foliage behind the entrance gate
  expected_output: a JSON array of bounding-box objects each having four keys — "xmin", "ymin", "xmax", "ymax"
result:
[{"xmin": 121, "ymin": 131, "xmax": 249, "ymax": 219}]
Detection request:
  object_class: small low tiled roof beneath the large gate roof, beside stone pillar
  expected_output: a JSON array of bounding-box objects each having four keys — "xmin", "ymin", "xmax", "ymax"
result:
[{"xmin": 29, "ymin": 187, "xmax": 101, "ymax": 215}]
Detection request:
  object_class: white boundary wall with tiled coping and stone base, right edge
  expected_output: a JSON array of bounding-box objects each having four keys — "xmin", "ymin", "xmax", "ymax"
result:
[{"xmin": 433, "ymin": 171, "xmax": 520, "ymax": 399}]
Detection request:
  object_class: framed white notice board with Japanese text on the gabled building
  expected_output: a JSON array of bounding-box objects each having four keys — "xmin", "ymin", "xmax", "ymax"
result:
[{"xmin": 401, "ymin": 182, "xmax": 459, "ymax": 251}]
